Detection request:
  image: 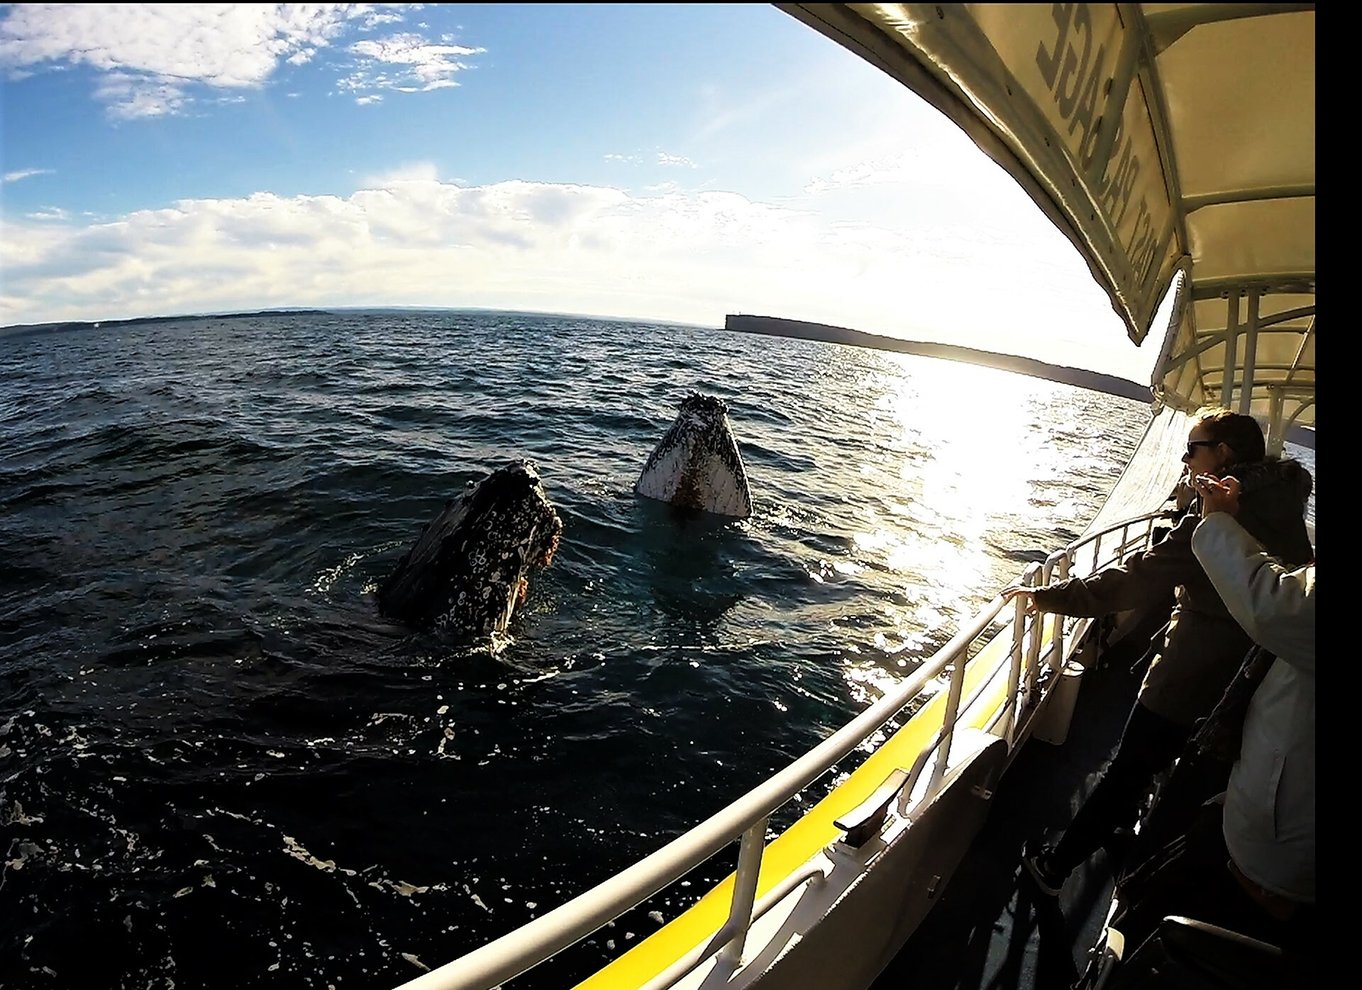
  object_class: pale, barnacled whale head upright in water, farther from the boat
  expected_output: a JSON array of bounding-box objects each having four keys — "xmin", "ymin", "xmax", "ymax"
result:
[{"xmin": 633, "ymin": 392, "xmax": 752, "ymax": 519}]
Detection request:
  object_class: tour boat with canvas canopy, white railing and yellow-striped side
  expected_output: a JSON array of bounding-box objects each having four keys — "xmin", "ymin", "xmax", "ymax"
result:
[{"xmin": 403, "ymin": 3, "xmax": 1316, "ymax": 990}]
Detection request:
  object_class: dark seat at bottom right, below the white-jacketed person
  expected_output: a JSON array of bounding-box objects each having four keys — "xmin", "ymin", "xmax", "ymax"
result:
[{"xmin": 1091, "ymin": 915, "xmax": 1290, "ymax": 990}]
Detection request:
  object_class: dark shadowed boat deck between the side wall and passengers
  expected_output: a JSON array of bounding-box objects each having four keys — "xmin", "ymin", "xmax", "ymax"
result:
[{"xmin": 872, "ymin": 659, "xmax": 1140, "ymax": 990}]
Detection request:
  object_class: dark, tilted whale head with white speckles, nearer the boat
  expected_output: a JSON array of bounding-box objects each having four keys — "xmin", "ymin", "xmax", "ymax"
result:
[{"xmin": 379, "ymin": 460, "xmax": 563, "ymax": 639}]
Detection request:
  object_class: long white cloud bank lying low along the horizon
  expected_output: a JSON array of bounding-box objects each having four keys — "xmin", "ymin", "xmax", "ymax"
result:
[{"xmin": 0, "ymin": 172, "xmax": 1133, "ymax": 373}]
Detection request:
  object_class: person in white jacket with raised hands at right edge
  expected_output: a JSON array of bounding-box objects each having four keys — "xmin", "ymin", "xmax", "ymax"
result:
[{"xmin": 1192, "ymin": 475, "xmax": 1314, "ymax": 919}]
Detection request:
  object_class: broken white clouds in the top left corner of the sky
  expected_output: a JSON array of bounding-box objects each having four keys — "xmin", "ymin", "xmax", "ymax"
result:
[{"xmin": 0, "ymin": 4, "xmax": 482, "ymax": 118}]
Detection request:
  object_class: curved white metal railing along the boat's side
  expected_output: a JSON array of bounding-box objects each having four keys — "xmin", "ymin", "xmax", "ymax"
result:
[{"xmin": 400, "ymin": 512, "xmax": 1167, "ymax": 990}]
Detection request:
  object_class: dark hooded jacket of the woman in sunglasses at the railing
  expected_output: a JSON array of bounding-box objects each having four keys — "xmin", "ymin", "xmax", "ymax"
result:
[{"xmin": 1035, "ymin": 458, "xmax": 1314, "ymax": 726}]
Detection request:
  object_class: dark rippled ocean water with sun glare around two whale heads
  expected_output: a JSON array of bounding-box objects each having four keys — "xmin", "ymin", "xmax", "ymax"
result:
[{"xmin": 0, "ymin": 312, "xmax": 1285, "ymax": 989}]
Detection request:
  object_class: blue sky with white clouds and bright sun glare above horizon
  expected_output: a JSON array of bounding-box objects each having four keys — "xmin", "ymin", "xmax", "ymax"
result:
[{"xmin": 0, "ymin": 4, "xmax": 1158, "ymax": 383}]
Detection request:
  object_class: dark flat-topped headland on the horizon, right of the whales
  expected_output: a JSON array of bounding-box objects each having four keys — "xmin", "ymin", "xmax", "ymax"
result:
[{"xmin": 723, "ymin": 313, "xmax": 1151, "ymax": 402}]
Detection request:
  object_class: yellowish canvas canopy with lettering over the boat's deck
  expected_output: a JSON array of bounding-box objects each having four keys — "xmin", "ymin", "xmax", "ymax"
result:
[{"xmin": 779, "ymin": 3, "xmax": 1314, "ymax": 445}]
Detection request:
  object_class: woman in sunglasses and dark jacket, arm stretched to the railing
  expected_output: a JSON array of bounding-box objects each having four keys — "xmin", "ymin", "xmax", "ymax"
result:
[{"xmin": 1004, "ymin": 409, "xmax": 1314, "ymax": 896}]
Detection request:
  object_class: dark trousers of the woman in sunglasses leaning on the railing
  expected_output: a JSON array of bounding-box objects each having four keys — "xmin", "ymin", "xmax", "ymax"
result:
[{"xmin": 1050, "ymin": 701, "xmax": 1193, "ymax": 873}]
